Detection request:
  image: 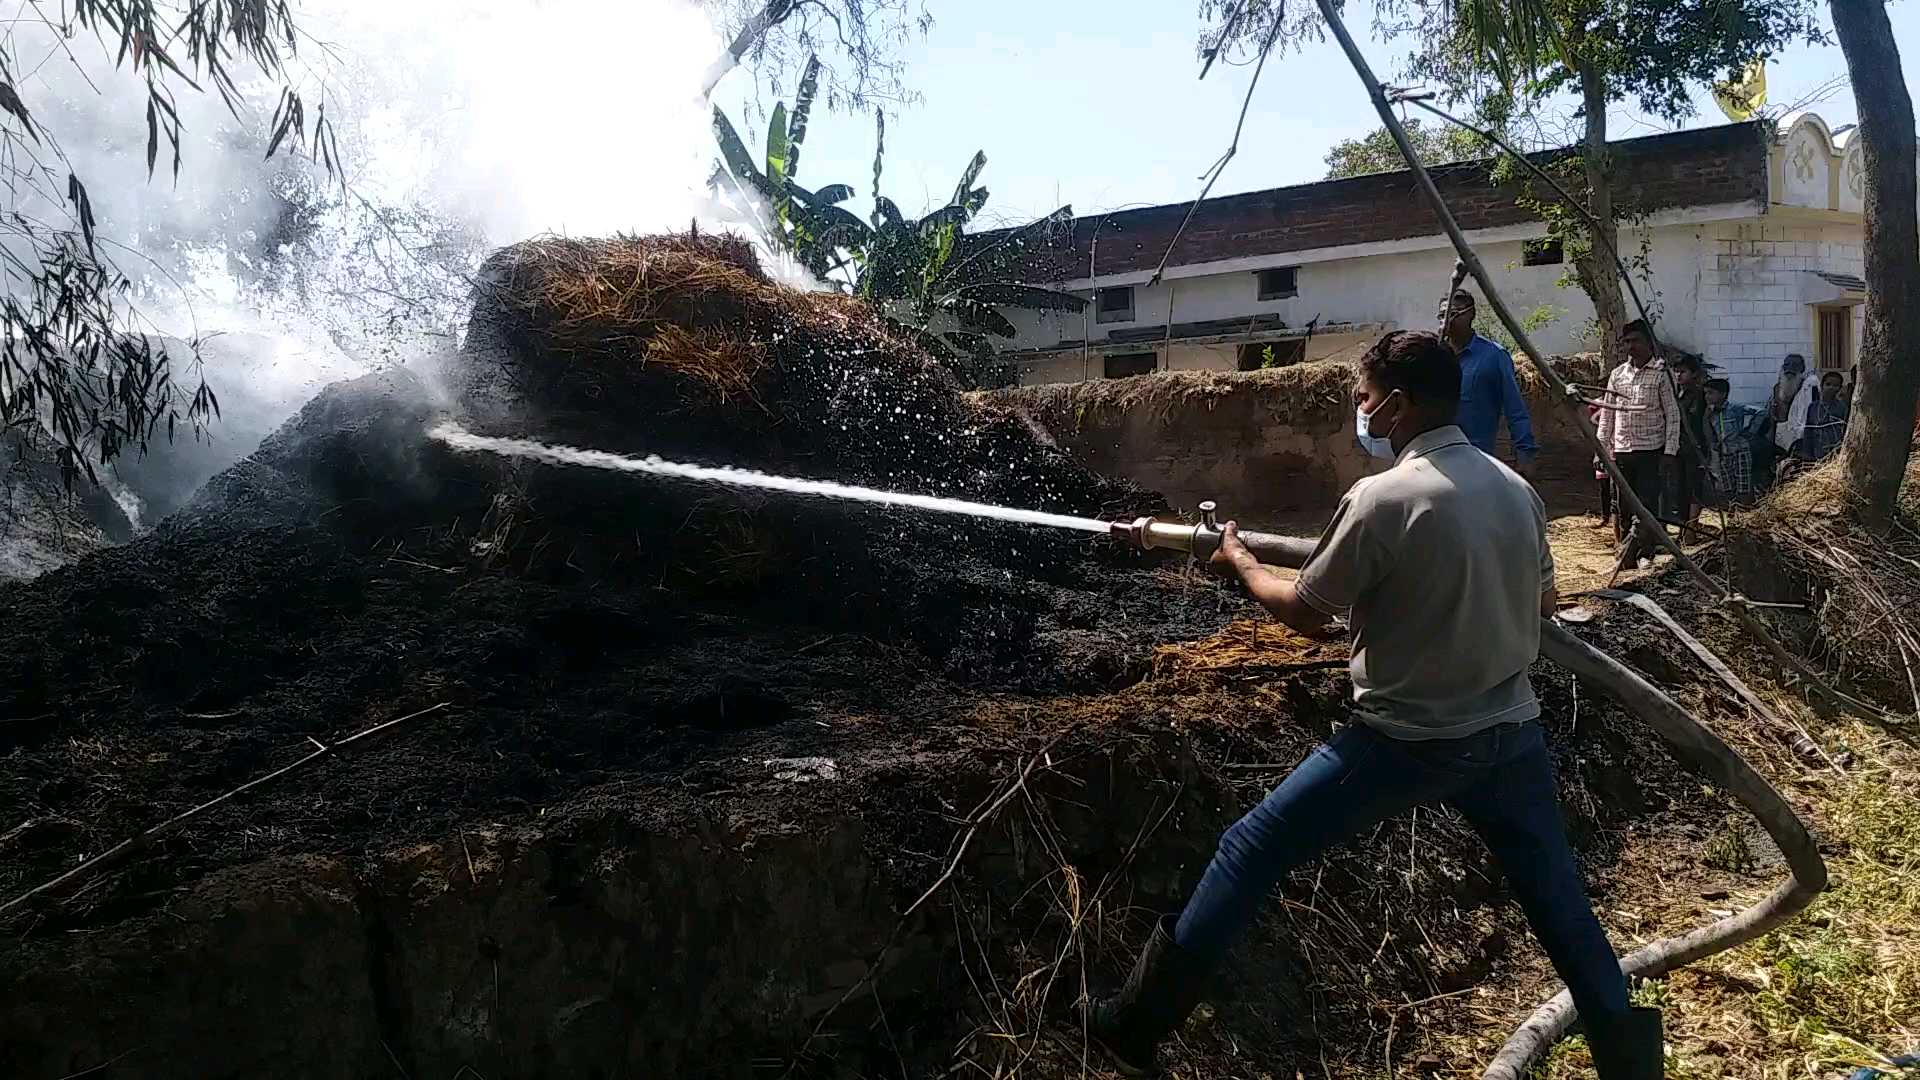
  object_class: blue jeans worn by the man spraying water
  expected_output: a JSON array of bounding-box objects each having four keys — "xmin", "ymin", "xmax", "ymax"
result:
[{"xmin": 1173, "ymin": 723, "xmax": 1628, "ymax": 1019}]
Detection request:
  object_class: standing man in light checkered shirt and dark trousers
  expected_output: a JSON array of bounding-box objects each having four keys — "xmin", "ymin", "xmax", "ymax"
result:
[{"xmin": 1599, "ymin": 319, "xmax": 1680, "ymax": 561}]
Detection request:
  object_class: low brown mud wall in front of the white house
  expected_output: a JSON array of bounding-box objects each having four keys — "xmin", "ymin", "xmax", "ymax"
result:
[{"xmin": 989, "ymin": 357, "xmax": 1596, "ymax": 519}]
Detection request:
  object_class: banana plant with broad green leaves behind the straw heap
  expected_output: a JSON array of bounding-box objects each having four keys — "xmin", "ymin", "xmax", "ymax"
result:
[{"xmin": 714, "ymin": 61, "xmax": 1087, "ymax": 386}]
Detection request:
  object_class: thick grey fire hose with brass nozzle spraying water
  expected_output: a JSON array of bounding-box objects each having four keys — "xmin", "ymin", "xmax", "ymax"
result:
[{"xmin": 1112, "ymin": 502, "xmax": 1826, "ymax": 1080}]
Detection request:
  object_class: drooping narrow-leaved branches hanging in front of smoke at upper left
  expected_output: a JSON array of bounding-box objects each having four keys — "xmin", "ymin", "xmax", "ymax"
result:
[{"xmin": 0, "ymin": 0, "xmax": 340, "ymax": 482}]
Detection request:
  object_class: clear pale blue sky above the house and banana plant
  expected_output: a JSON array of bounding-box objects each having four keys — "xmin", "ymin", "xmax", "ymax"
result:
[{"xmin": 716, "ymin": 0, "xmax": 1920, "ymax": 221}]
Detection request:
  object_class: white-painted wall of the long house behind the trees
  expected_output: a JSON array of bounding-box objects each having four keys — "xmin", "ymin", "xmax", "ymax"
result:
[{"xmin": 1006, "ymin": 113, "xmax": 1889, "ymax": 404}]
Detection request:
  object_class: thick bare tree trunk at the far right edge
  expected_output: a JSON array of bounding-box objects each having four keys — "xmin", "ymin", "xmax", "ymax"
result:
[{"xmin": 1832, "ymin": 0, "xmax": 1920, "ymax": 521}]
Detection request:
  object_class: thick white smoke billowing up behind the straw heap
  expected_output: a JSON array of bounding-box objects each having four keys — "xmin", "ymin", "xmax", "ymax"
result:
[{"xmin": 0, "ymin": 0, "xmax": 722, "ymax": 517}]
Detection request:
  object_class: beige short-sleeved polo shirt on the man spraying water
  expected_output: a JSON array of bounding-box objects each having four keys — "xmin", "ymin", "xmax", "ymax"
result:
[{"xmin": 1300, "ymin": 427, "xmax": 1553, "ymax": 740}]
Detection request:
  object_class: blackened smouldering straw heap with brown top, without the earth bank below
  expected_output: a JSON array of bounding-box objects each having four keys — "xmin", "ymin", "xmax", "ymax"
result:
[{"xmin": 0, "ymin": 236, "xmax": 1225, "ymax": 924}]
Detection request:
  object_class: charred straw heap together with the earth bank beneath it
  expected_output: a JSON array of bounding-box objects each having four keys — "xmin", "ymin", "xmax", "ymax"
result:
[{"xmin": 0, "ymin": 236, "xmax": 1697, "ymax": 1078}]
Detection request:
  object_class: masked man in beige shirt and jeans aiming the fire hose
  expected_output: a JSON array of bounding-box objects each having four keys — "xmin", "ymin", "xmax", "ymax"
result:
[{"xmin": 1087, "ymin": 332, "xmax": 1663, "ymax": 1080}]
